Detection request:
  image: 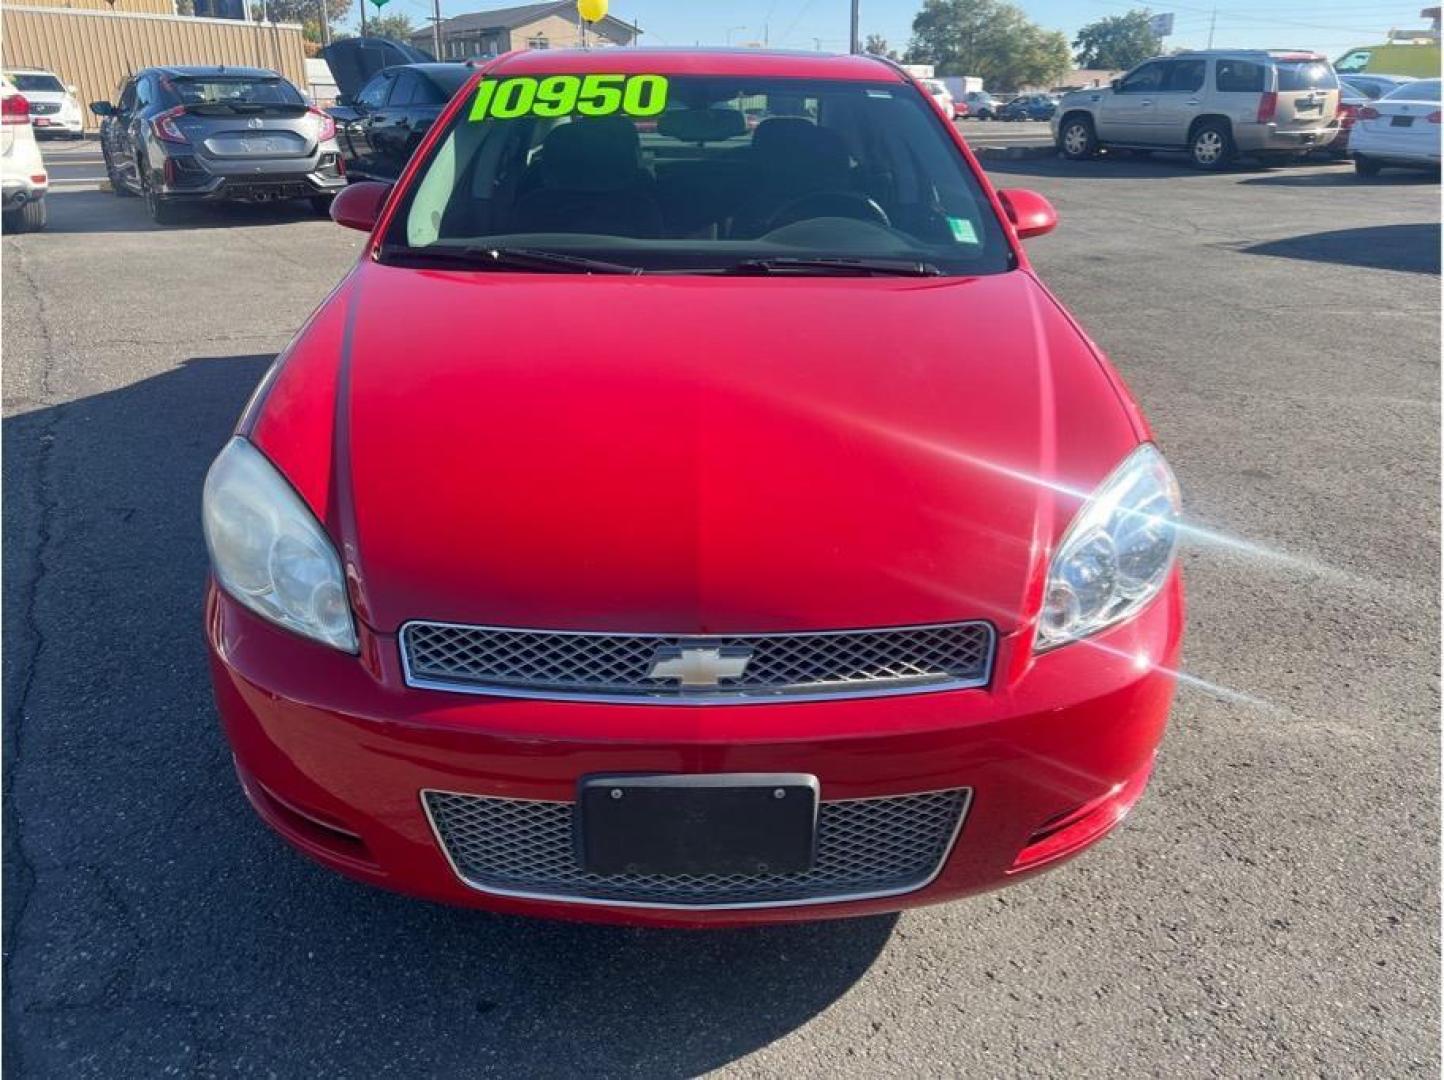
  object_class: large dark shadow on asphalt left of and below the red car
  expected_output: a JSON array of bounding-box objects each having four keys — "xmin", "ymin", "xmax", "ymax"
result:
[{"xmin": 0, "ymin": 355, "xmax": 895, "ymax": 1077}]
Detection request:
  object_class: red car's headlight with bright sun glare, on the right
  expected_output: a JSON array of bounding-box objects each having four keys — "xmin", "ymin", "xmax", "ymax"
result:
[{"xmin": 1034, "ymin": 443, "xmax": 1180, "ymax": 653}]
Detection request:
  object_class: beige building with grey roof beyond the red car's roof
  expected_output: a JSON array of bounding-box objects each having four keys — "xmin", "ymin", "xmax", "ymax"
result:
[{"xmin": 412, "ymin": 0, "xmax": 641, "ymax": 61}]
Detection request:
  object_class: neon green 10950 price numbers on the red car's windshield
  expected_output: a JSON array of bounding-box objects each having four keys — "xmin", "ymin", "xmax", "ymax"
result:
[{"xmin": 468, "ymin": 75, "xmax": 667, "ymax": 120}]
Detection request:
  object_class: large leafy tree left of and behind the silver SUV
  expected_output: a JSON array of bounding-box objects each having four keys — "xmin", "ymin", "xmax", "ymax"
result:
[{"xmin": 907, "ymin": 0, "xmax": 1071, "ymax": 91}]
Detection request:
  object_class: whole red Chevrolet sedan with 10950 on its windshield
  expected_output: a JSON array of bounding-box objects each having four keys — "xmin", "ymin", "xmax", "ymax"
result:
[{"xmin": 204, "ymin": 49, "xmax": 1183, "ymax": 926}]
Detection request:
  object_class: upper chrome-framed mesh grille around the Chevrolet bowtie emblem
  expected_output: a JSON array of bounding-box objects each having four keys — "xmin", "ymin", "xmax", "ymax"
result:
[{"xmin": 401, "ymin": 622, "xmax": 993, "ymax": 703}]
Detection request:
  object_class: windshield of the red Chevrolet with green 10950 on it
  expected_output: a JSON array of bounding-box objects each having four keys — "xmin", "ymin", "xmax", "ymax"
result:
[{"xmin": 383, "ymin": 75, "xmax": 1012, "ymax": 274}]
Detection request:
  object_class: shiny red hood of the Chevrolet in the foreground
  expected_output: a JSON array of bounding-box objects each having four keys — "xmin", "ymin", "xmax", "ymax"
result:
[{"xmin": 254, "ymin": 263, "xmax": 1139, "ymax": 634}]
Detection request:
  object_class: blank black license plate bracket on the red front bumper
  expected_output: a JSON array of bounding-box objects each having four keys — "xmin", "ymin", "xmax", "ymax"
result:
[{"xmin": 576, "ymin": 772, "xmax": 819, "ymax": 876}]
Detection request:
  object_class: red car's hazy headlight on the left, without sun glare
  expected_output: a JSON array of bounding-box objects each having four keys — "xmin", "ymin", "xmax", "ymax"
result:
[{"xmin": 201, "ymin": 437, "xmax": 357, "ymax": 653}]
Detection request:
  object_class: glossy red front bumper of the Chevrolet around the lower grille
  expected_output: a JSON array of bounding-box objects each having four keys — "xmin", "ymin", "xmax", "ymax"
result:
[{"xmin": 206, "ymin": 578, "xmax": 1183, "ymax": 926}]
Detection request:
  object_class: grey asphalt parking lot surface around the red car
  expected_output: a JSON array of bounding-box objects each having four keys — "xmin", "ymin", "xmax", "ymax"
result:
[{"xmin": 0, "ymin": 147, "xmax": 1440, "ymax": 1077}]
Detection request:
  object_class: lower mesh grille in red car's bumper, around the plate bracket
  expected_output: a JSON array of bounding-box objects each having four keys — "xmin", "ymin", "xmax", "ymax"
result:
[{"xmin": 423, "ymin": 788, "xmax": 970, "ymax": 907}]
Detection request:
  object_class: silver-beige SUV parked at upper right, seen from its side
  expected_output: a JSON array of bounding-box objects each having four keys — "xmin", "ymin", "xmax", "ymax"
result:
[{"xmin": 1051, "ymin": 49, "xmax": 1339, "ymax": 169}]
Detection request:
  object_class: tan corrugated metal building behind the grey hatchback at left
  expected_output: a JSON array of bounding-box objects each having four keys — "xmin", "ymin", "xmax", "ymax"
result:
[{"xmin": 0, "ymin": 0, "xmax": 306, "ymax": 129}]
